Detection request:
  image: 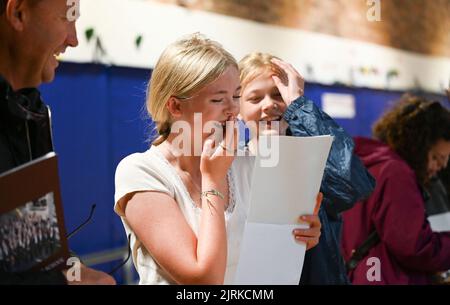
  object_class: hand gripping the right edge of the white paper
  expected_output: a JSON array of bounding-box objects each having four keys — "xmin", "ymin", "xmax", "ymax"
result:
[{"xmin": 293, "ymin": 193, "xmax": 323, "ymax": 250}]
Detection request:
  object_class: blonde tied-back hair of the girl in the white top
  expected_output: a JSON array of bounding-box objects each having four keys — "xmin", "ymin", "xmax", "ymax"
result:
[{"xmin": 146, "ymin": 33, "xmax": 238, "ymax": 145}]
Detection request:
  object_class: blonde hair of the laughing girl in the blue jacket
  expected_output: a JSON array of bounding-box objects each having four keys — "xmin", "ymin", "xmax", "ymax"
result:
[{"xmin": 239, "ymin": 52, "xmax": 284, "ymax": 90}]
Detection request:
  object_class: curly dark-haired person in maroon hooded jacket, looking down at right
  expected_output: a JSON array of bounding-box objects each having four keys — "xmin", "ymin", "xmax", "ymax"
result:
[{"xmin": 342, "ymin": 95, "xmax": 450, "ymax": 285}]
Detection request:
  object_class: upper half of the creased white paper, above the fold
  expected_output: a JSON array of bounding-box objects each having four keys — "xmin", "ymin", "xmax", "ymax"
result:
[{"xmin": 248, "ymin": 136, "xmax": 333, "ymax": 224}]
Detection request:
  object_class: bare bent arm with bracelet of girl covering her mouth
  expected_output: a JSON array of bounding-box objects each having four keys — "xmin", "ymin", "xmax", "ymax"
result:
[{"xmin": 125, "ymin": 139, "xmax": 234, "ymax": 285}]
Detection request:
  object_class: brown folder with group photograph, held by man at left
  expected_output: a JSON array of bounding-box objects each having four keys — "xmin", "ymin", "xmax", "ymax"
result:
[{"xmin": 0, "ymin": 153, "xmax": 69, "ymax": 272}]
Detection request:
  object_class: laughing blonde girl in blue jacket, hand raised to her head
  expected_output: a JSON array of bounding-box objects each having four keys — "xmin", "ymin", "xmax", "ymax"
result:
[{"xmin": 239, "ymin": 53, "xmax": 375, "ymax": 285}]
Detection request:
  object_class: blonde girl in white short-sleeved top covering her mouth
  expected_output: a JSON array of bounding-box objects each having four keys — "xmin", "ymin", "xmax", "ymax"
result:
[{"xmin": 115, "ymin": 34, "xmax": 320, "ymax": 284}]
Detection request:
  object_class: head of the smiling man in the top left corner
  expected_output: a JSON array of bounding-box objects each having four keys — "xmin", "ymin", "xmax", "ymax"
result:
[{"xmin": 0, "ymin": 0, "xmax": 78, "ymax": 89}]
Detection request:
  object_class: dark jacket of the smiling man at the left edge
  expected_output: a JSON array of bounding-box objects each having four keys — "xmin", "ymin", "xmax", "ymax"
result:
[{"xmin": 0, "ymin": 75, "xmax": 66, "ymax": 285}]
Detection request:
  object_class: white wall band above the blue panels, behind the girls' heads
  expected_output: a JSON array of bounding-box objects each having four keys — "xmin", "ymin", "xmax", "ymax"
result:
[{"xmin": 63, "ymin": 0, "xmax": 450, "ymax": 93}]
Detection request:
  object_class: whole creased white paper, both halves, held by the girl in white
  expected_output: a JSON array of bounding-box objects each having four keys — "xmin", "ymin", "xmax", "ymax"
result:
[{"xmin": 234, "ymin": 136, "xmax": 333, "ymax": 285}]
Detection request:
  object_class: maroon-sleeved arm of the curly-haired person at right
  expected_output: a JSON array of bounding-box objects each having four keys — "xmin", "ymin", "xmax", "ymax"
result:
[{"xmin": 372, "ymin": 164, "xmax": 450, "ymax": 272}]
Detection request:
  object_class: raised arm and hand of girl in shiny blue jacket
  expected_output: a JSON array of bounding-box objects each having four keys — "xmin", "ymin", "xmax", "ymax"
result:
[{"xmin": 273, "ymin": 60, "xmax": 375, "ymax": 214}]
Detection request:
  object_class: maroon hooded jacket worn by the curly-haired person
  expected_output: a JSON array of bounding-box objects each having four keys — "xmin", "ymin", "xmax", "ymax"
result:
[{"xmin": 342, "ymin": 138, "xmax": 450, "ymax": 285}]
